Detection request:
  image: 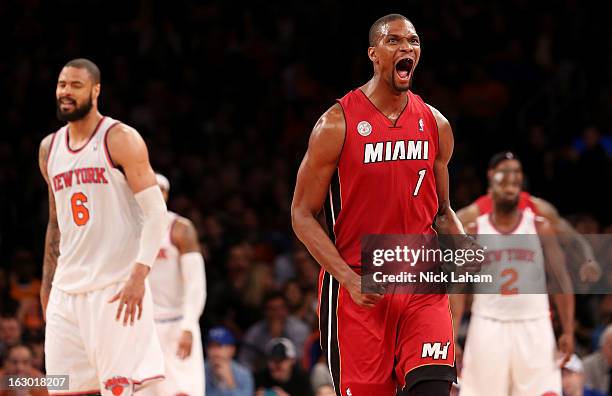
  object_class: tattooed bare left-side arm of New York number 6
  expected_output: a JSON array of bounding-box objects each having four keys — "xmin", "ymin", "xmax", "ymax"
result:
[{"xmin": 38, "ymin": 135, "xmax": 60, "ymax": 318}]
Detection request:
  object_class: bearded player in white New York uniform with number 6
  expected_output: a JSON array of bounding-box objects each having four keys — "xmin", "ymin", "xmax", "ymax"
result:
[{"xmin": 39, "ymin": 59, "xmax": 167, "ymax": 395}]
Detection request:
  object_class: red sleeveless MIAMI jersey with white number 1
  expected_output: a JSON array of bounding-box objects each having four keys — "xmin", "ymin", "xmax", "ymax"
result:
[{"xmin": 325, "ymin": 89, "xmax": 438, "ymax": 267}]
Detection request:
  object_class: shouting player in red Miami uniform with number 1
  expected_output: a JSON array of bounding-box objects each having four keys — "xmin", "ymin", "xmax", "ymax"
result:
[{"xmin": 292, "ymin": 14, "xmax": 474, "ymax": 396}]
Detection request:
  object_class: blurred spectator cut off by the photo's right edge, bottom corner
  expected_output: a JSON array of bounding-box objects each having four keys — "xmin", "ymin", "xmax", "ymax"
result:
[{"xmin": 583, "ymin": 325, "xmax": 612, "ymax": 394}]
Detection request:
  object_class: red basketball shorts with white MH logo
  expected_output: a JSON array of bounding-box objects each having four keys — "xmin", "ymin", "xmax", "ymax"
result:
[{"xmin": 319, "ymin": 270, "xmax": 456, "ymax": 396}]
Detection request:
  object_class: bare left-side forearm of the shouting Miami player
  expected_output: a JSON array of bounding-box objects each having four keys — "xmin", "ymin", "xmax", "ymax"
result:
[{"xmin": 292, "ymin": 211, "xmax": 353, "ymax": 283}]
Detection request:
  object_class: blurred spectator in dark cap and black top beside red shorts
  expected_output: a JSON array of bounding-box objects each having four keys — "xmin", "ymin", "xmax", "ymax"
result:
[{"xmin": 255, "ymin": 337, "xmax": 312, "ymax": 396}]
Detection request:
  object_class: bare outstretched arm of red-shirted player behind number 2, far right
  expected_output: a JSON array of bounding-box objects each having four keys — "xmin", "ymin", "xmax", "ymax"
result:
[{"xmin": 531, "ymin": 196, "xmax": 601, "ymax": 282}]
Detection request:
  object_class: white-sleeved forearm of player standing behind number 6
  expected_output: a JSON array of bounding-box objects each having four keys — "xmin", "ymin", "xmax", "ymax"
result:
[{"xmin": 180, "ymin": 252, "xmax": 206, "ymax": 331}]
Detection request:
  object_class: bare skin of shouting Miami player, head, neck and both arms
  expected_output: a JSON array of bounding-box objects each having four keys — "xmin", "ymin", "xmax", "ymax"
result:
[{"xmin": 291, "ymin": 19, "xmax": 464, "ymax": 307}]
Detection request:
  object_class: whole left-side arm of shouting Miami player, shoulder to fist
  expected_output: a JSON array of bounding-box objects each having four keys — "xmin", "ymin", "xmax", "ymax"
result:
[{"xmin": 291, "ymin": 104, "xmax": 376, "ymax": 306}]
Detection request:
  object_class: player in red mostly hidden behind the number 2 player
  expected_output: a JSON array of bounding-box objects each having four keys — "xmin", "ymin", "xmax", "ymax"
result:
[{"xmin": 457, "ymin": 151, "xmax": 601, "ymax": 282}]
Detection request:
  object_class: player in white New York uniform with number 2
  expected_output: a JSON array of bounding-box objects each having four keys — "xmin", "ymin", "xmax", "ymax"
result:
[{"xmin": 451, "ymin": 162, "xmax": 574, "ymax": 396}]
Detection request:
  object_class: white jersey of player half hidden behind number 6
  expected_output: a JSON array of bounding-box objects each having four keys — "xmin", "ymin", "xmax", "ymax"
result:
[{"xmin": 148, "ymin": 212, "xmax": 183, "ymax": 320}]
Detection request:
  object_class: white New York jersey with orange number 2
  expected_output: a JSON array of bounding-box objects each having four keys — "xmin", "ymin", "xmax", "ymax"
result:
[{"xmin": 472, "ymin": 209, "xmax": 550, "ymax": 321}]
